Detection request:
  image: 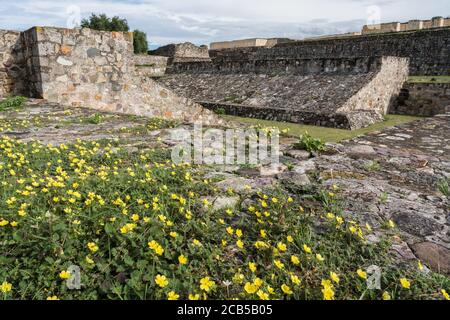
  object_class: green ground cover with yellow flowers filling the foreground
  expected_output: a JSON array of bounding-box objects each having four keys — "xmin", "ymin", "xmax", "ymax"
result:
[{"xmin": 0, "ymin": 133, "xmax": 450, "ymax": 300}]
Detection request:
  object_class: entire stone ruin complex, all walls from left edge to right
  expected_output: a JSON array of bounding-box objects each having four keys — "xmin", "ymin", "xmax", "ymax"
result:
[{"xmin": 0, "ymin": 27, "xmax": 450, "ymax": 129}]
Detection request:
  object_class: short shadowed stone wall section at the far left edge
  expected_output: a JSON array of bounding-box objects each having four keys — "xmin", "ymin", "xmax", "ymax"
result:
[{"xmin": 0, "ymin": 30, "xmax": 27, "ymax": 97}]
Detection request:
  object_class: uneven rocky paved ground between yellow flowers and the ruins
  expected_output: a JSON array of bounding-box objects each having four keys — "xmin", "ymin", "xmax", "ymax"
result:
[{"xmin": 0, "ymin": 101, "xmax": 450, "ymax": 273}]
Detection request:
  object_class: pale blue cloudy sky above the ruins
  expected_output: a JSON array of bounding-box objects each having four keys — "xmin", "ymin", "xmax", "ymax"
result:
[{"xmin": 0, "ymin": 0, "xmax": 450, "ymax": 47}]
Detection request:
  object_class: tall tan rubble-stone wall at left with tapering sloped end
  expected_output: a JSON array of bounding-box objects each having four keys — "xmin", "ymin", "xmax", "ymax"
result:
[{"xmin": 3, "ymin": 27, "xmax": 217, "ymax": 124}]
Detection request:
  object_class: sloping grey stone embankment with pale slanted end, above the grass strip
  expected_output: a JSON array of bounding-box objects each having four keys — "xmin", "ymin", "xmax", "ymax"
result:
[{"xmin": 159, "ymin": 57, "xmax": 408, "ymax": 129}]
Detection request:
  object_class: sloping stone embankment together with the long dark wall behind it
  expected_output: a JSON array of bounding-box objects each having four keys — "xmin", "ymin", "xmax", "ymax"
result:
[{"xmin": 156, "ymin": 28, "xmax": 450, "ymax": 129}]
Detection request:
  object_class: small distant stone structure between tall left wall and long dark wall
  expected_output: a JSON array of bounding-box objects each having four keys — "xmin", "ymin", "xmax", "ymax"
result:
[{"xmin": 150, "ymin": 42, "xmax": 210, "ymax": 64}]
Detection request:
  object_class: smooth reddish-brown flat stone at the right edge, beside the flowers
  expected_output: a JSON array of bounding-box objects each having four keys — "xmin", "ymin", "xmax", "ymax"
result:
[{"xmin": 412, "ymin": 242, "xmax": 450, "ymax": 274}]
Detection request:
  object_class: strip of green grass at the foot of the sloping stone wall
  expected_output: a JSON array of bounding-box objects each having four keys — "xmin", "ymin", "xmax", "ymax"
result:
[{"xmin": 223, "ymin": 114, "xmax": 422, "ymax": 142}]
